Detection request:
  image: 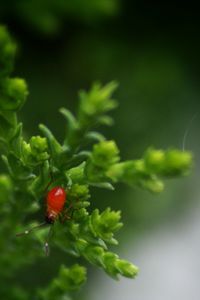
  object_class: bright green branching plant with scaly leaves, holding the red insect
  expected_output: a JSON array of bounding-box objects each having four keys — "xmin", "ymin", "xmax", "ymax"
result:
[{"xmin": 0, "ymin": 26, "xmax": 192, "ymax": 299}]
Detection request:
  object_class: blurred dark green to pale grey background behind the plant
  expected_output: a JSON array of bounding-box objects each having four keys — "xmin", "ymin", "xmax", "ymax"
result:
[{"xmin": 0, "ymin": 0, "xmax": 200, "ymax": 300}]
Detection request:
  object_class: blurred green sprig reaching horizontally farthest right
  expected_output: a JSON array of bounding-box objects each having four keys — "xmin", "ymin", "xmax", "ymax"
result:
[{"xmin": 106, "ymin": 148, "xmax": 192, "ymax": 193}]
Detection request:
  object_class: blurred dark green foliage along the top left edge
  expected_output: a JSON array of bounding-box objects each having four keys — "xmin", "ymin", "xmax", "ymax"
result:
[{"xmin": 0, "ymin": 0, "xmax": 119, "ymax": 34}]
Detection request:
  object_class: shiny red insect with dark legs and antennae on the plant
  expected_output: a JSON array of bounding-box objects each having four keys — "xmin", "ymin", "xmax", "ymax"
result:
[{"xmin": 16, "ymin": 186, "xmax": 68, "ymax": 255}]
